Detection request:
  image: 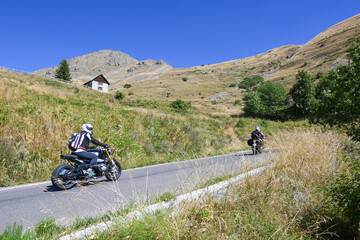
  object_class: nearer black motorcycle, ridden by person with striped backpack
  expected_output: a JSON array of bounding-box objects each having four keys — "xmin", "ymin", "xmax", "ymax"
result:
[{"xmin": 51, "ymin": 147, "xmax": 122, "ymax": 190}]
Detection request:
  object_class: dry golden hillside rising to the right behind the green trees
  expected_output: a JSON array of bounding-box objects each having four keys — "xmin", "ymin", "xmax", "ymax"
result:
[{"xmin": 115, "ymin": 15, "xmax": 360, "ymax": 115}]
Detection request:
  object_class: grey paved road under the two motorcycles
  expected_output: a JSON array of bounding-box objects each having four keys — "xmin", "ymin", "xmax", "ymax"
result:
[{"xmin": 0, "ymin": 151, "xmax": 270, "ymax": 233}]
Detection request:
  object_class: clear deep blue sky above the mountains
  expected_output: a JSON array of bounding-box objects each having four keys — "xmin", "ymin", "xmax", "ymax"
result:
[{"xmin": 0, "ymin": 0, "xmax": 360, "ymax": 71}]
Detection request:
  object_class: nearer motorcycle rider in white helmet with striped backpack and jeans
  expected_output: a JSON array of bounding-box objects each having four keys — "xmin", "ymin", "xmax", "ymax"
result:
[{"xmin": 73, "ymin": 124, "xmax": 109, "ymax": 176}]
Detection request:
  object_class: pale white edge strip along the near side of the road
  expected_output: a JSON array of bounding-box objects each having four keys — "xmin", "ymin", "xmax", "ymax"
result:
[{"xmin": 59, "ymin": 164, "xmax": 273, "ymax": 240}]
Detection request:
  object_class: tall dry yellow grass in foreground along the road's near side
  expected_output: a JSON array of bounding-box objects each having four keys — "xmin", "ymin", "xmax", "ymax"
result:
[{"xmin": 92, "ymin": 129, "xmax": 350, "ymax": 239}]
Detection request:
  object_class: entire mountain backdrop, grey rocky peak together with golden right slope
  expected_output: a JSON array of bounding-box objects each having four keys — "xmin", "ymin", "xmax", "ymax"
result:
[{"xmin": 33, "ymin": 14, "xmax": 360, "ymax": 114}]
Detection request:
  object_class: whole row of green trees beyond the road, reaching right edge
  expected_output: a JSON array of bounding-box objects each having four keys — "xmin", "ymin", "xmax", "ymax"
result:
[{"xmin": 243, "ymin": 36, "xmax": 360, "ymax": 141}]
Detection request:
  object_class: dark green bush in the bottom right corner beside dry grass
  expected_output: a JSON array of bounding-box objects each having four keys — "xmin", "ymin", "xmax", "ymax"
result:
[{"xmin": 302, "ymin": 147, "xmax": 360, "ymax": 239}]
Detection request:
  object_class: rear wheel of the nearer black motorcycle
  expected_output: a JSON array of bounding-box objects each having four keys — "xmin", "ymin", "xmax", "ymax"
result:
[{"xmin": 51, "ymin": 164, "xmax": 76, "ymax": 190}]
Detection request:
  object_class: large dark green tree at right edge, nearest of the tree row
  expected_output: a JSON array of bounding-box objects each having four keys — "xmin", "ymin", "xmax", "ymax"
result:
[{"xmin": 312, "ymin": 36, "xmax": 360, "ymax": 141}]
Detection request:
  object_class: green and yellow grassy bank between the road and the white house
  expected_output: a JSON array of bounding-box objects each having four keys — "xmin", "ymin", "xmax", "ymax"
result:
[{"xmin": 0, "ymin": 70, "xmax": 306, "ymax": 186}]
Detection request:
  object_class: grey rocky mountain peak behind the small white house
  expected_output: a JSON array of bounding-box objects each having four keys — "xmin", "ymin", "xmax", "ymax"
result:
[{"xmin": 33, "ymin": 50, "xmax": 172, "ymax": 88}]
